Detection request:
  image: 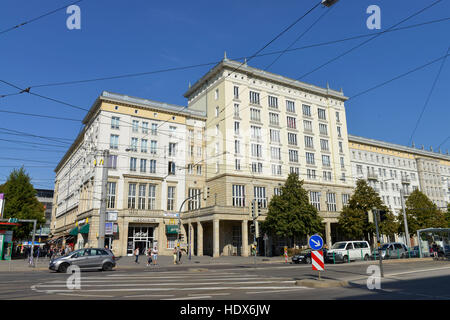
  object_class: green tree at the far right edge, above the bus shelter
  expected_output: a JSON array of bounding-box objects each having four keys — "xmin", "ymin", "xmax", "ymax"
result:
[{"xmin": 400, "ymin": 190, "xmax": 448, "ymax": 234}]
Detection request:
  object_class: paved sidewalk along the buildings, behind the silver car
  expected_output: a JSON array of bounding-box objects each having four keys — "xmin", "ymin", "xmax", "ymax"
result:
[{"xmin": 0, "ymin": 255, "xmax": 290, "ymax": 272}]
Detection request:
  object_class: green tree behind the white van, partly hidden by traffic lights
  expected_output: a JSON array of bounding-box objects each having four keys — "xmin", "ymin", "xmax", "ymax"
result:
[{"xmin": 338, "ymin": 179, "xmax": 398, "ymax": 241}]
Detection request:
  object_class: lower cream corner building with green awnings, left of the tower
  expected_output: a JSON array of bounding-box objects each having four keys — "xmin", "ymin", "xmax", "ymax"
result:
[{"xmin": 52, "ymin": 92, "xmax": 204, "ymax": 256}]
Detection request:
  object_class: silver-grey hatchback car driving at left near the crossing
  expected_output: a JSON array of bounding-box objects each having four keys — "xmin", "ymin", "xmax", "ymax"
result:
[{"xmin": 48, "ymin": 248, "xmax": 116, "ymax": 272}]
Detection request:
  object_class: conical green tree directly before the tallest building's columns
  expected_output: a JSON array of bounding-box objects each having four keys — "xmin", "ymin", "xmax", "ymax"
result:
[{"xmin": 261, "ymin": 173, "xmax": 323, "ymax": 242}]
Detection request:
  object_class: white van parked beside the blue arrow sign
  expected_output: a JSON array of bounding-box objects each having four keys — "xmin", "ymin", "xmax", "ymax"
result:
[{"xmin": 325, "ymin": 241, "xmax": 370, "ymax": 263}]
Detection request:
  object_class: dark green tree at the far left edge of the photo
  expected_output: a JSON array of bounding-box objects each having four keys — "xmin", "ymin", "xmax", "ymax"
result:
[{"xmin": 0, "ymin": 167, "xmax": 45, "ymax": 239}]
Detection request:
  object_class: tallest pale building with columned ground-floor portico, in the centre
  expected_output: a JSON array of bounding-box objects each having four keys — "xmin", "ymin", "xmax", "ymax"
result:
[{"xmin": 182, "ymin": 58, "xmax": 353, "ymax": 257}]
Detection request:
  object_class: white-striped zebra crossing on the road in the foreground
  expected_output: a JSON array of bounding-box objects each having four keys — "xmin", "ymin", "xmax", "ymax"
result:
[{"xmin": 31, "ymin": 270, "xmax": 311, "ymax": 300}]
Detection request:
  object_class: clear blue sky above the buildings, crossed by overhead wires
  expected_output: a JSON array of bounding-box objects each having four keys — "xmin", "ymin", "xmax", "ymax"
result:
[{"xmin": 0, "ymin": 0, "xmax": 450, "ymax": 189}]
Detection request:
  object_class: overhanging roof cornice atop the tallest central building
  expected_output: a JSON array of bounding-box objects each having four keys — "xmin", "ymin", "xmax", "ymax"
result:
[{"xmin": 184, "ymin": 59, "xmax": 348, "ymax": 101}]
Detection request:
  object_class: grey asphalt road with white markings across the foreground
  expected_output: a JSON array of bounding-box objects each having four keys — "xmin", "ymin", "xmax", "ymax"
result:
[{"xmin": 0, "ymin": 261, "xmax": 450, "ymax": 300}]
